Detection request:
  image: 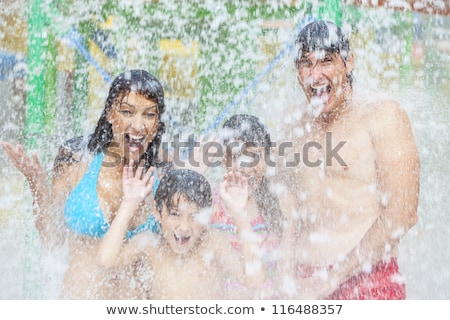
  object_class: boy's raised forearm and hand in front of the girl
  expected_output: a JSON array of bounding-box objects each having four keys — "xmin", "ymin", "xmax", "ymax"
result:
[{"xmin": 220, "ymin": 173, "xmax": 265, "ymax": 288}]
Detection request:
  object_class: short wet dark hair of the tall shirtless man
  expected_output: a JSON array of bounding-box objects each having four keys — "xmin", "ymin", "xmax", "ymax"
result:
[{"xmin": 295, "ymin": 20, "xmax": 354, "ymax": 85}]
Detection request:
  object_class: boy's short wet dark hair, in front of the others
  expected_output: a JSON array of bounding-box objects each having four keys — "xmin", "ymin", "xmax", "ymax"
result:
[{"xmin": 155, "ymin": 169, "xmax": 212, "ymax": 212}]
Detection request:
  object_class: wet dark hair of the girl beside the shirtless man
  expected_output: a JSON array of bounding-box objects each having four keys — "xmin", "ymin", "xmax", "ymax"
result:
[{"xmin": 222, "ymin": 114, "xmax": 283, "ymax": 236}]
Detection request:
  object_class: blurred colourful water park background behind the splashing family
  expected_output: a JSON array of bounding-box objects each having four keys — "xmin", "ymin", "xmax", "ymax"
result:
[{"xmin": 0, "ymin": 0, "xmax": 450, "ymax": 299}]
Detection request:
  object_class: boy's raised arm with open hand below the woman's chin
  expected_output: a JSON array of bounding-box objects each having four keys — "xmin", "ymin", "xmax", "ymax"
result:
[{"xmin": 97, "ymin": 163, "xmax": 154, "ymax": 268}]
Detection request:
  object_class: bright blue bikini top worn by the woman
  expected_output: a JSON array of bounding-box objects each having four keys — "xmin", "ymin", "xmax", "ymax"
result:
[{"xmin": 64, "ymin": 152, "xmax": 159, "ymax": 239}]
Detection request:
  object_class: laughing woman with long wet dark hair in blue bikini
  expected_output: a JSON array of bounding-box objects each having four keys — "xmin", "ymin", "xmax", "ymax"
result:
[{"xmin": 1, "ymin": 70, "xmax": 165, "ymax": 299}]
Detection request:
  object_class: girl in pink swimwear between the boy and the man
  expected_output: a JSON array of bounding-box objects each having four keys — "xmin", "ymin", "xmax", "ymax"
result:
[{"xmin": 211, "ymin": 114, "xmax": 283, "ymax": 298}]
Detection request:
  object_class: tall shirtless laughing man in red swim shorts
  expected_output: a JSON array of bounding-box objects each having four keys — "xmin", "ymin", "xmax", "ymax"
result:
[{"xmin": 276, "ymin": 21, "xmax": 419, "ymax": 299}]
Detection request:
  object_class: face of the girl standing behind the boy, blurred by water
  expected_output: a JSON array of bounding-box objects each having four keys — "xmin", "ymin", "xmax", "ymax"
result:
[{"xmin": 224, "ymin": 141, "xmax": 266, "ymax": 191}]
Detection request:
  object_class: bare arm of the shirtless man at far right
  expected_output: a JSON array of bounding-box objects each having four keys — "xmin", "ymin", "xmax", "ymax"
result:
[{"xmin": 338, "ymin": 101, "xmax": 420, "ymax": 286}]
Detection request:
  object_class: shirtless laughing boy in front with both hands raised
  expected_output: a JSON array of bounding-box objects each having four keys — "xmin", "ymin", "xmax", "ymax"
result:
[{"xmin": 98, "ymin": 166, "xmax": 264, "ymax": 300}]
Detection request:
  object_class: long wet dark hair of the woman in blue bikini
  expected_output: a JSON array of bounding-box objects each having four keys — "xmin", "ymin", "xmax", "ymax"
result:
[{"xmin": 88, "ymin": 70, "xmax": 166, "ymax": 168}]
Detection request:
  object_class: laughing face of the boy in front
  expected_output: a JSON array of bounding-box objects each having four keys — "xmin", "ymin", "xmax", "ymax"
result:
[{"xmin": 160, "ymin": 193, "xmax": 208, "ymax": 254}]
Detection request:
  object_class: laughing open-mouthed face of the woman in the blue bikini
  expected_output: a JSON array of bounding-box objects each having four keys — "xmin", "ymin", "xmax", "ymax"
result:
[{"xmin": 108, "ymin": 92, "xmax": 159, "ymax": 161}]
